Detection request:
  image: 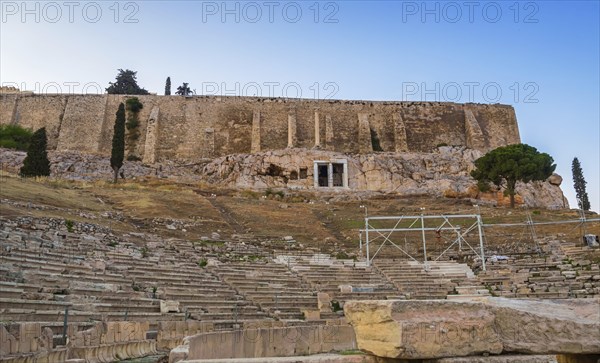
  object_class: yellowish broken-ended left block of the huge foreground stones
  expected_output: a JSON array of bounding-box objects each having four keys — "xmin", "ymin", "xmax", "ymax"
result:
[{"xmin": 344, "ymin": 300, "xmax": 502, "ymax": 359}]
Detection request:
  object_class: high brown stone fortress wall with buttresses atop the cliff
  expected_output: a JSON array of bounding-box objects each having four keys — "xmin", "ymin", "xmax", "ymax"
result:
[{"xmin": 0, "ymin": 94, "xmax": 520, "ymax": 163}]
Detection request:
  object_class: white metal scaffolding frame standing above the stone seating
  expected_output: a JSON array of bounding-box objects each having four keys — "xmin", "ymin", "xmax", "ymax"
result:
[{"xmin": 360, "ymin": 214, "xmax": 486, "ymax": 271}]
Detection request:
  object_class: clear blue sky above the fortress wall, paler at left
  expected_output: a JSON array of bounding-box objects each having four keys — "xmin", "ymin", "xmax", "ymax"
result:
[{"xmin": 0, "ymin": 1, "xmax": 600, "ymax": 211}]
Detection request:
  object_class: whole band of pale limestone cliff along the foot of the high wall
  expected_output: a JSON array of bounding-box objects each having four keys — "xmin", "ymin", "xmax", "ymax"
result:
[{"xmin": 0, "ymin": 147, "xmax": 569, "ymax": 209}]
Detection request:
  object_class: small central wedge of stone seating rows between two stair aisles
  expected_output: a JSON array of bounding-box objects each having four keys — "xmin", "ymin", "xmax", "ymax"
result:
[{"xmin": 215, "ymin": 261, "xmax": 317, "ymax": 320}]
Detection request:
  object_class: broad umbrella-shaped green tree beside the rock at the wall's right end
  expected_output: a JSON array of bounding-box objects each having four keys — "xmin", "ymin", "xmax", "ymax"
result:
[{"xmin": 471, "ymin": 144, "xmax": 556, "ymax": 208}]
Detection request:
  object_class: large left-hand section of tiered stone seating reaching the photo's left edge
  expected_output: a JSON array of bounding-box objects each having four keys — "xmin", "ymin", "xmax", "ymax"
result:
[{"xmin": 0, "ymin": 220, "xmax": 268, "ymax": 325}]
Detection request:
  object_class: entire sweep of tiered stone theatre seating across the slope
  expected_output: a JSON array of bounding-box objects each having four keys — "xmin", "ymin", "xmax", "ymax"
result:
[{"xmin": 0, "ymin": 213, "xmax": 600, "ymax": 363}]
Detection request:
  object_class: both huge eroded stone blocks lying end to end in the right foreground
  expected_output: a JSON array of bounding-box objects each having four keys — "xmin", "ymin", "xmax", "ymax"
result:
[{"xmin": 344, "ymin": 297, "xmax": 600, "ymax": 359}]
